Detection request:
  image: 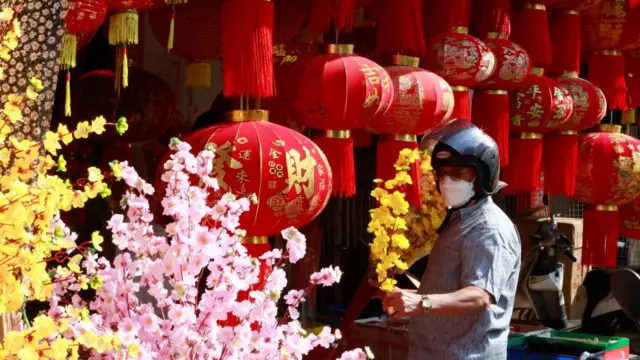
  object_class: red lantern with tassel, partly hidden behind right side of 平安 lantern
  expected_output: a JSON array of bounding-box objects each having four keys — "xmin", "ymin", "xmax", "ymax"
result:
[{"xmin": 543, "ymin": 75, "xmax": 607, "ymax": 196}]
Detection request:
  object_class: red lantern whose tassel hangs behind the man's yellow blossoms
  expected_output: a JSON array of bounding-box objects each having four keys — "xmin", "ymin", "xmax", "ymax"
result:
[{"xmin": 370, "ymin": 56, "xmax": 454, "ymax": 206}]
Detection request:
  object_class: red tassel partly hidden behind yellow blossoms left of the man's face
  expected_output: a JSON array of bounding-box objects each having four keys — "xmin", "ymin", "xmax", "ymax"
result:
[{"xmin": 376, "ymin": 136, "xmax": 422, "ymax": 207}]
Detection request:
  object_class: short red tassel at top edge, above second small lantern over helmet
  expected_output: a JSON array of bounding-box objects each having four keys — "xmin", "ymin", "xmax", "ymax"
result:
[{"xmin": 471, "ymin": 0, "xmax": 511, "ymax": 39}]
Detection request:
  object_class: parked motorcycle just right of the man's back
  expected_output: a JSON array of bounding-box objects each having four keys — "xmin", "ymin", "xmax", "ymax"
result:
[{"xmin": 514, "ymin": 215, "xmax": 576, "ymax": 330}]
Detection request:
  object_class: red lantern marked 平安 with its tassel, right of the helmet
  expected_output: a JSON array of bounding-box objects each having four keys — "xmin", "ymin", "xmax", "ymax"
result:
[{"xmin": 502, "ymin": 70, "xmax": 573, "ymax": 193}]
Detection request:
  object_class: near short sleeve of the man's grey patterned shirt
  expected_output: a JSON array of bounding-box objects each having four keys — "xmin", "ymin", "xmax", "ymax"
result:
[{"xmin": 462, "ymin": 228, "xmax": 517, "ymax": 303}]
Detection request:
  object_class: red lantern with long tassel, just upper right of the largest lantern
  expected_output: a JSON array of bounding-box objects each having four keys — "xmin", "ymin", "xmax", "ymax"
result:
[{"xmin": 294, "ymin": 45, "xmax": 393, "ymax": 197}]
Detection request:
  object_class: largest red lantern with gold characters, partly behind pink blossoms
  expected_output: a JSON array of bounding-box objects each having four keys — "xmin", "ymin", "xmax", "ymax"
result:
[{"xmin": 184, "ymin": 115, "xmax": 332, "ymax": 237}]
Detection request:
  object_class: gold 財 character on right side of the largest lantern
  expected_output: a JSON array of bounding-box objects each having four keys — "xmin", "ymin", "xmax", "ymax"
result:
[{"xmin": 284, "ymin": 147, "xmax": 316, "ymax": 199}]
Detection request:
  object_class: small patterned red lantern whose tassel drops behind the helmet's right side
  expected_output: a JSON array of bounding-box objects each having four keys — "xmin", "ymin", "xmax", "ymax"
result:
[{"xmin": 471, "ymin": 33, "xmax": 531, "ymax": 166}]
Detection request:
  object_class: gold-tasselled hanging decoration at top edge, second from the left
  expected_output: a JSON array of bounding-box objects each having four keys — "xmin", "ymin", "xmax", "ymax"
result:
[{"xmin": 109, "ymin": 0, "xmax": 153, "ymax": 94}]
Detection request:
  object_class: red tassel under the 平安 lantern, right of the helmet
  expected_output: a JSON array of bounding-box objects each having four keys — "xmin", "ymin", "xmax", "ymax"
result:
[{"xmin": 502, "ymin": 137, "xmax": 542, "ymax": 194}]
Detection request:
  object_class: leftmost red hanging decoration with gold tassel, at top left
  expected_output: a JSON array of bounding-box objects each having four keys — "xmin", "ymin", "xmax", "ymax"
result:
[{"xmin": 60, "ymin": 0, "xmax": 107, "ymax": 116}]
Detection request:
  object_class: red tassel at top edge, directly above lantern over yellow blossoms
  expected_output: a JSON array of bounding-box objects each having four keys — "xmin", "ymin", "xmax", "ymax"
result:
[{"xmin": 376, "ymin": 0, "xmax": 425, "ymax": 57}]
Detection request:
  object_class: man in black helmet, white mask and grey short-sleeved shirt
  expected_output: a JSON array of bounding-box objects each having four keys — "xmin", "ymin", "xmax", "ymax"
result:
[{"xmin": 383, "ymin": 120, "xmax": 521, "ymax": 360}]
